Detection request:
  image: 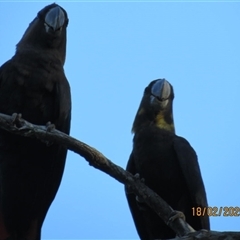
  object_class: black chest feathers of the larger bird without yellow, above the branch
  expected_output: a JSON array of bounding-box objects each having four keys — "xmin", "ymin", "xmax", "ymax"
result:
[{"xmin": 0, "ymin": 54, "xmax": 68, "ymax": 124}]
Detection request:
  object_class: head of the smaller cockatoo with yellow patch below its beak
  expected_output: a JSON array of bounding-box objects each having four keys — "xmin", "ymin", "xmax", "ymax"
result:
[{"xmin": 132, "ymin": 79, "xmax": 175, "ymax": 133}]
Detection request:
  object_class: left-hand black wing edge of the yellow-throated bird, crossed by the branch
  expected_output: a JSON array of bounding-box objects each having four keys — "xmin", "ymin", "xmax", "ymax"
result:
[{"xmin": 125, "ymin": 153, "xmax": 149, "ymax": 239}]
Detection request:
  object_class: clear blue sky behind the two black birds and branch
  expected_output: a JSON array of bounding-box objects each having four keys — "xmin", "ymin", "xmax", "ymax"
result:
[{"xmin": 0, "ymin": 1, "xmax": 240, "ymax": 239}]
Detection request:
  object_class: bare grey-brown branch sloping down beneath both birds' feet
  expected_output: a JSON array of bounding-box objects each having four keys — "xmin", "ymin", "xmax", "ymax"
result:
[{"xmin": 0, "ymin": 113, "xmax": 240, "ymax": 240}]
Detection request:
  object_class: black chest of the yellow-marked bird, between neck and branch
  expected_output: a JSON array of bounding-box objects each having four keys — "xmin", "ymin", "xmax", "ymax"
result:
[{"xmin": 133, "ymin": 131, "xmax": 184, "ymax": 201}]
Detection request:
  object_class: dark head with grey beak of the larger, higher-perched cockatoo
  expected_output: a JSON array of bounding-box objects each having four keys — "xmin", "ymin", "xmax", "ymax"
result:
[{"xmin": 17, "ymin": 3, "xmax": 68, "ymax": 63}]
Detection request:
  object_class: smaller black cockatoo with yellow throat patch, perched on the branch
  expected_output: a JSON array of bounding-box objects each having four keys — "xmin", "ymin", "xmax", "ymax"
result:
[{"xmin": 125, "ymin": 79, "xmax": 210, "ymax": 240}]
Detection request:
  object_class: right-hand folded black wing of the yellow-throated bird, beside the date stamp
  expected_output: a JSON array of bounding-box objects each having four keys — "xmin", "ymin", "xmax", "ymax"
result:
[{"xmin": 173, "ymin": 136, "xmax": 210, "ymax": 230}]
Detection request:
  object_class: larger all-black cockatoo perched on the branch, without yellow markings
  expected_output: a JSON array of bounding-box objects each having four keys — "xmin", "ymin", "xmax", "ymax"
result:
[{"xmin": 0, "ymin": 4, "xmax": 71, "ymax": 240}]
